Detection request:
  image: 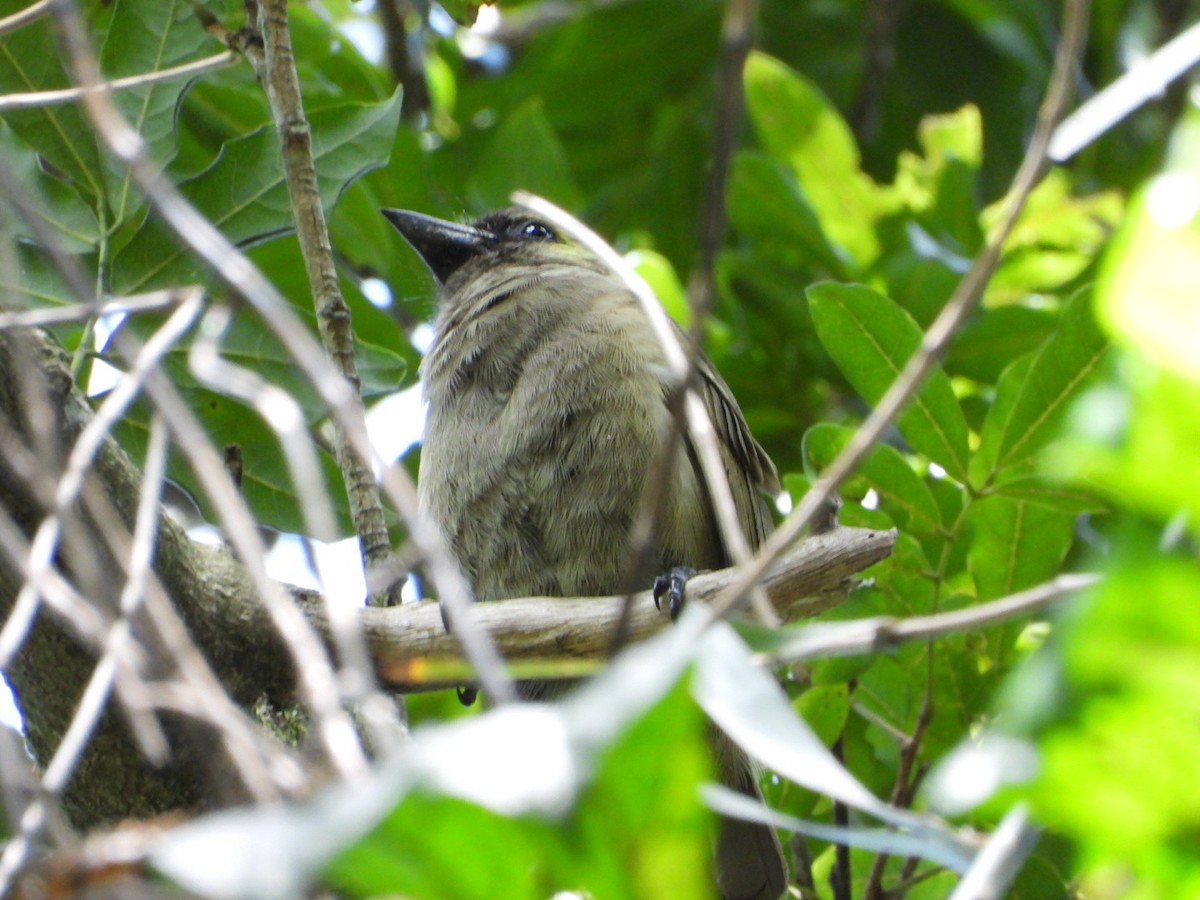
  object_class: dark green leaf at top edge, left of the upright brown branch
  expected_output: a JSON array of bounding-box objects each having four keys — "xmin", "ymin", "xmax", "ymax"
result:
[{"xmin": 100, "ymin": 0, "xmax": 221, "ymax": 222}]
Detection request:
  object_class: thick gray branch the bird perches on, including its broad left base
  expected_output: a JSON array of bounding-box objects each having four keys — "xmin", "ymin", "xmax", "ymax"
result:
[{"xmin": 0, "ymin": 330, "xmax": 894, "ymax": 824}]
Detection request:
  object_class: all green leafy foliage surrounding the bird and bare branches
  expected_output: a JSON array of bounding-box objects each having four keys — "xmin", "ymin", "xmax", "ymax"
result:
[{"xmin": 0, "ymin": 0, "xmax": 1200, "ymax": 898}]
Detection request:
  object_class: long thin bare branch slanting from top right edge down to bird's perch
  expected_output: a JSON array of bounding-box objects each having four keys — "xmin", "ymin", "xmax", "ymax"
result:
[{"xmin": 715, "ymin": 0, "xmax": 1088, "ymax": 613}]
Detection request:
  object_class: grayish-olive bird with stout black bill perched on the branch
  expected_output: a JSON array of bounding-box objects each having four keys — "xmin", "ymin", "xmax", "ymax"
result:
[{"xmin": 382, "ymin": 208, "xmax": 787, "ymax": 900}]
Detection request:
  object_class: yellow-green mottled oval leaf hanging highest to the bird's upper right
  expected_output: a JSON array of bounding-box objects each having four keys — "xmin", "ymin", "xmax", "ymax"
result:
[{"xmin": 744, "ymin": 52, "xmax": 880, "ymax": 266}]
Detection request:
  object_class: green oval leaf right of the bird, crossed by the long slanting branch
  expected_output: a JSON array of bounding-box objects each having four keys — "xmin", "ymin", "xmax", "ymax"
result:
[{"xmin": 808, "ymin": 282, "xmax": 967, "ymax": 481}]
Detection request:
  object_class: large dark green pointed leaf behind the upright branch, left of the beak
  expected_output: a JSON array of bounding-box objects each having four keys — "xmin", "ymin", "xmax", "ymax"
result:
[{"xmin": 113, "ymin": 90, "xmax": 400, "ymax": 293}]
